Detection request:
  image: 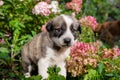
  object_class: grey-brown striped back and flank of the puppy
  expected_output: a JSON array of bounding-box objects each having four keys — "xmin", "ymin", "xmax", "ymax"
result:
[{"xmin": 21, "ymin": 32, "xmax": 49, "ymax": 64}]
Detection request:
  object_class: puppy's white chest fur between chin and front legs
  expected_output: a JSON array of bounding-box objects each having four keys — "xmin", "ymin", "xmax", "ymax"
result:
[{"xmin": 46, "ymin": 47, "xmax": 70, "ymax": 65}]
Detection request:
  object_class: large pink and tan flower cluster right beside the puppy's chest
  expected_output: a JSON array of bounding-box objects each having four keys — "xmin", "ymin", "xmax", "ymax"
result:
[{"xmin": 67, "ymin": 42, "xmax": 99, "ymax": 77}]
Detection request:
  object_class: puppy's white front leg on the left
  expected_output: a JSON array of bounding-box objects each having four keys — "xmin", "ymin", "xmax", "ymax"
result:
[{"xmin": 38, "ymin": 58, "xmax": 49, "ymax": 79}]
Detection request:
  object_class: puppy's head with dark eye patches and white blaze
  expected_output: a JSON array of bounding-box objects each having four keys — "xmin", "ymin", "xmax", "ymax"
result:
[{"xmin": 46, "ymin": 15, "xmax": 81, "ymax": 47}]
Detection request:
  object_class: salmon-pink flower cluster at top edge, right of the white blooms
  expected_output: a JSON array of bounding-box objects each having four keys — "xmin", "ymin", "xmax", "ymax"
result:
[{"xmin": 66, "ymin": 0, "xmax": 82, "ymax": 13}]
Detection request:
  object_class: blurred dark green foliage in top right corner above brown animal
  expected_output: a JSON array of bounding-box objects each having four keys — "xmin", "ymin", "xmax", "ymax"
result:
[{"xmin": 79, "ymin": 0, "xmax": 120, "ymax": 23}]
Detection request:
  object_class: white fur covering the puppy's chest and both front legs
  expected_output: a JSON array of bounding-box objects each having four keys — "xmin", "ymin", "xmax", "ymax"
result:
[{"xmin": 38, "ymin": 47, "xmax": 70, "ymax": 79}]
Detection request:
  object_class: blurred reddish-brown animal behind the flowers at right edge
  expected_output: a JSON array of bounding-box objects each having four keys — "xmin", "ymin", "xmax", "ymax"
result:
[{"xmin": 93, "ymin": 20, "xmax": 120, "ymax": 47}]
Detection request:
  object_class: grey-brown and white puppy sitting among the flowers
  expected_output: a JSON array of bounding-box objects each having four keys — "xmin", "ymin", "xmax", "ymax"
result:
[{"xmin": 21, "ymin": 14, "xmax": 81, "ymax": 79}]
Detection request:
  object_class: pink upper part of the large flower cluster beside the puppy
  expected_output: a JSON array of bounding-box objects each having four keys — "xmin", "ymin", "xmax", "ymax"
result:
[{"xmin": 71, "ymin": 42, "xmax": 98, "ymax": 64}]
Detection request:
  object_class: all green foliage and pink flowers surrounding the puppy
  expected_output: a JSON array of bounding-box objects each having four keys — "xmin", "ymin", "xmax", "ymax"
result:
[{"xmin": 0, "ymin": 0, "xmax": 120, "ymax": 80}]
